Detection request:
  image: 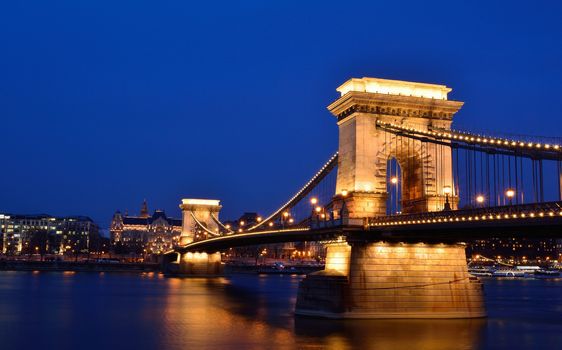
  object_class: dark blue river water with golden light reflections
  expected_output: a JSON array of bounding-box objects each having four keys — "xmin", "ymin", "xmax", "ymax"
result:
[{"xmin": 0, "ymin": 272, "xmax": 562, "ymax": 350}]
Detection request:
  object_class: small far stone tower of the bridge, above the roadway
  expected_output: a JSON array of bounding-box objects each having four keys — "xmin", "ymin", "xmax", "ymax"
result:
[{"xmin": 180, "ymin": 198, "xmax": 222, "ymax": 245}]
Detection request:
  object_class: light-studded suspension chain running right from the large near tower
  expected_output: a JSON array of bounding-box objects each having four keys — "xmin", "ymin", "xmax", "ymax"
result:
[{"xmin": 377, "ymin": 120, "xmax": 562, "ymax": 151}]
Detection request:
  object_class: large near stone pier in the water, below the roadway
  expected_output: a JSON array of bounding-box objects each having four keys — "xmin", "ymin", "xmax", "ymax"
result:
[{"xmin": 295, "ymin": 242, "xmax": 486, "ymax": 318}]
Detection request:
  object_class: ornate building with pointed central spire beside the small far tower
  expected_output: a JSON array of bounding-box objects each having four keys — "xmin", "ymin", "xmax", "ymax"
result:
[{"xmin": 110, "ymin": 201, "xmax": 182, "ymax": 254}]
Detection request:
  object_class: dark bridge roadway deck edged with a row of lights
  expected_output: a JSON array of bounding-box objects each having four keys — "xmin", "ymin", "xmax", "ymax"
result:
[{"xmin": 176, "ymin": 202, "xmax": 562, "ymax": 253}]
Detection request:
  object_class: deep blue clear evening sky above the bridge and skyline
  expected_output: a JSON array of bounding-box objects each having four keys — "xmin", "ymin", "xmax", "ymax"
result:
[{"xmin": 0, "ymin": 0, "xmax": 562, "ymax": 227}]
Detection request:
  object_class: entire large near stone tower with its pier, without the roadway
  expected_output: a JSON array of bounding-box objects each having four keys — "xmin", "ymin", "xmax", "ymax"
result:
[{"xmin": 295, "ymin": 78, "xmax": 486, "ymax": 318}]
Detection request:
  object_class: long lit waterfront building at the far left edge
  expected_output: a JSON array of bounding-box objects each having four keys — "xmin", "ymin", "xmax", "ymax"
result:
[{"xmin": 0, "ymin": 214, "xmax": 101, "ymax": 255}]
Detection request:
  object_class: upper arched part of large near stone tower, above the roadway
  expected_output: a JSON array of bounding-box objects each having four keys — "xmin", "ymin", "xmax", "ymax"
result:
[{"xmin": 328, "ymin": 78, "xmax": 463, "ymax": 218}]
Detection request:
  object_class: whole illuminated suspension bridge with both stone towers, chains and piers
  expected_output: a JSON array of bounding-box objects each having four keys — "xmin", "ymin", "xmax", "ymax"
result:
[{"xmin": 165, "ymin": 78, "xmax": 562, "ymax": 318}]
